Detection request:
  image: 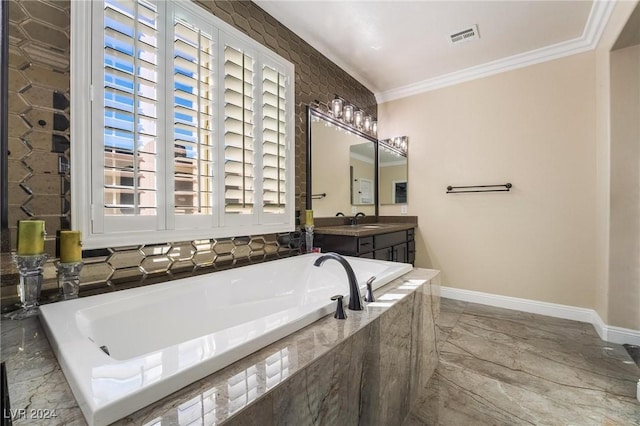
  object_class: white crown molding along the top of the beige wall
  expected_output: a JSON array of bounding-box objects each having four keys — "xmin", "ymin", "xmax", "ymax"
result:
[{"xmin": 375, "ymin": 0, "xmax": 616, "ymax": 104}]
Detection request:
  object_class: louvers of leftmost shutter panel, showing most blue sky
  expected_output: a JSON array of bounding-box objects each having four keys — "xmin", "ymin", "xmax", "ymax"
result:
[{"xmin": 93, "ymin": 0, "xmax": 161, "ymax": 232}]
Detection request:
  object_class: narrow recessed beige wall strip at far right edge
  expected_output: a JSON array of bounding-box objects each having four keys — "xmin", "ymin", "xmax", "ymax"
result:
[{"xmin": 608, "ymin": 45, "xmax": 640, "ymax": 330}]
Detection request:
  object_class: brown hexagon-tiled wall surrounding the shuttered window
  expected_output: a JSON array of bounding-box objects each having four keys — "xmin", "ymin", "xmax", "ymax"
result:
[{"xmin": 1, "ymin": 0, "xmax": 377, "ymax": 309}]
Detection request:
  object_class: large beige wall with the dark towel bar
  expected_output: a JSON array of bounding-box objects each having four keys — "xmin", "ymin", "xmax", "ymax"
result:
[{"xmin": 379, "ymin": 52, "xmax": 596, "ymax": 307}]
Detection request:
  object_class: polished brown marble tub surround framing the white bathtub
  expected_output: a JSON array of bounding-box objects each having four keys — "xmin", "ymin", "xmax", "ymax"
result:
[{"xmin": 2, "ymin": 265, "xmax": 440, "ymax": 425}]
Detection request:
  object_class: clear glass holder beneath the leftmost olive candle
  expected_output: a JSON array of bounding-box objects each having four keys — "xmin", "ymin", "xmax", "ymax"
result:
[{"xmin": 5, "ymin": 253, "xmax": 49, "ymax": 320}]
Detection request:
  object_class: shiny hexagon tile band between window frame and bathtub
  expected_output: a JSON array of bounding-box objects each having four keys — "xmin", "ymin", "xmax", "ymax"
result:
[{"xmin": 2, "ymin": 232, "xmax": 301, "ymax": 311}]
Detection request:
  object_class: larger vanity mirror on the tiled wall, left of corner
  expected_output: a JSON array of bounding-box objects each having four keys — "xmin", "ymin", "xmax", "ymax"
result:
[{"xmin": 306, "ymin": 107, "xmax": 378, "ymax": 217}]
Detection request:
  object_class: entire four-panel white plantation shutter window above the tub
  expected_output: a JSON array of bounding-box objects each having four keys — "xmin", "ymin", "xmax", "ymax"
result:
[{"xmin": 80, "ymin": 0, "xmax": 295, "ymax": 248}]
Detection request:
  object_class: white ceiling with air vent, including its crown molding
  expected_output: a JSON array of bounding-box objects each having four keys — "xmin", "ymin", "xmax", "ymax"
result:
[{"xmin": 253, "ymin": 0, "xmax": 613, "ymax": 102}]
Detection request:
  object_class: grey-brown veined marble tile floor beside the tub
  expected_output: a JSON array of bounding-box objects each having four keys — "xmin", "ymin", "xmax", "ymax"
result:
[{"xmin": 403, "ymin": 298, "xmax": 640, "ymax": 426}]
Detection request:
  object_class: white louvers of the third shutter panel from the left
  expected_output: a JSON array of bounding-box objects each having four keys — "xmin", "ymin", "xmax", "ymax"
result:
[{"xmin": 224, "ymin": 45, "xmax": 255, "ymax": 214}]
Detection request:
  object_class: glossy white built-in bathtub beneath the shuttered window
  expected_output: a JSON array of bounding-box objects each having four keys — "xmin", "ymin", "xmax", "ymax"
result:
[{"xmin": 40, "ymin": 254, "xmax": 412, "ymax": 425}]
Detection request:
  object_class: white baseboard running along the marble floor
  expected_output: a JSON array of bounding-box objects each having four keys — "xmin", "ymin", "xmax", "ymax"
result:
[{"xmin": 440, "ymin": 286, "xmax": 640, "ymax": 345}]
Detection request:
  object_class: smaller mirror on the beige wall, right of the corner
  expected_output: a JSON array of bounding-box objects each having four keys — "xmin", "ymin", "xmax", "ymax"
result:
[{"xmin": 378, "ymin": 136, "xmax": 408, "ymax": 205}]
